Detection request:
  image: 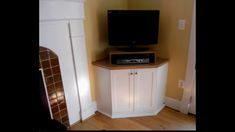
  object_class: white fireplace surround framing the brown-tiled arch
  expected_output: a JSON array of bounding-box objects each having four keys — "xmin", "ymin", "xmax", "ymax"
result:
[{"xmin": 39, "ymin": 0, "xmax": 96, "ymax": 125}]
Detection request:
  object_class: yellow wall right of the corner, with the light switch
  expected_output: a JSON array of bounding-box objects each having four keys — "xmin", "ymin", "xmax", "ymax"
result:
[{"xmin": 128, "ymin": 0, "xmax": 193, "ymax": 100}]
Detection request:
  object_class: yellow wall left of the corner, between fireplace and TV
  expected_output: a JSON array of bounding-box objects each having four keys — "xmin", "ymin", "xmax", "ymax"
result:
[{"xmin": 84, "ymin": 0, "xmax": 127, "ymax": 101}]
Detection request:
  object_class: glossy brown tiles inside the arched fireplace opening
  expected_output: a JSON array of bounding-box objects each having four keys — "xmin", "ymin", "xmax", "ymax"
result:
[{"xmin": 39, "ymin": 46, "xmax": 69, "ymax": 127}]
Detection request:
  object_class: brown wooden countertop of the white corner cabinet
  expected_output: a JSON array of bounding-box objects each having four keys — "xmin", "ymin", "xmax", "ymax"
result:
[{"xmin": 92, "ymin": 58, "xmax": 169, "ymax": 70}]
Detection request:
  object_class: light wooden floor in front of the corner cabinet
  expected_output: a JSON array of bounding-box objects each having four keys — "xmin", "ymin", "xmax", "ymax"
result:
[{"xmin": 69, "ymin": 107, "xmax": 196, "ymax": 130}]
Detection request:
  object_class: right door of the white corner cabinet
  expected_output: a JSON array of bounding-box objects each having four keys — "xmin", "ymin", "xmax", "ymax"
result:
[{"xmin": 134, "ymin": 68, "xmax": 156, "ymax": 112}]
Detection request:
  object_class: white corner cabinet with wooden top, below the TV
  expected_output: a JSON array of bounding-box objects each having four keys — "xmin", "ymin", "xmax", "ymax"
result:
[{"xmin": 93, "ymin": 58, "xmax": 168, "ymax": 118}]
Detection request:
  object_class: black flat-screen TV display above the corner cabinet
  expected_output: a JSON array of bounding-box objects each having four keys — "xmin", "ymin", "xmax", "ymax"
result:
[{"xmin": 108, "ymin": 10, "xmax": 160, "ymax": 47}]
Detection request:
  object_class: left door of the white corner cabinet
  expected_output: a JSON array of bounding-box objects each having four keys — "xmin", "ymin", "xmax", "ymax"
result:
[{"xmin": 111, "ymin": 70, "xmax": 133, "ymax": 113}]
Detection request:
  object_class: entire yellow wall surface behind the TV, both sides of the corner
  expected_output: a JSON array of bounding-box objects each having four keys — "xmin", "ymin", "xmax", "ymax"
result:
[{"xmin": 84, "ymin": 0, "xmax": 193, "ymax": 100}]
